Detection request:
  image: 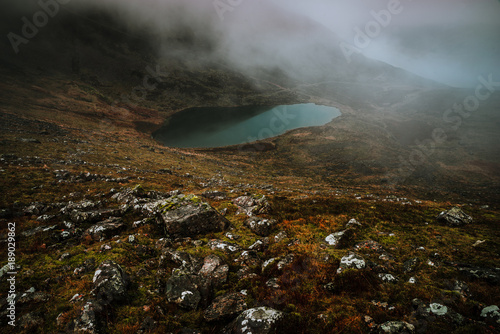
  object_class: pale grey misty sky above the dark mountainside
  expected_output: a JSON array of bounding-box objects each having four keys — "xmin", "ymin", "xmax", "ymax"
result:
[{"xmin": 0, "ymin": 0, "xmax": 500, "ymax": 87}]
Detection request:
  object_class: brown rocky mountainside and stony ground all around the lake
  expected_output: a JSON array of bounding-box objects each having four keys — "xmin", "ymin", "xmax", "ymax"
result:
[{"xmin": 0, "ymin": 2, "xmax": 500, "ymax": 333}]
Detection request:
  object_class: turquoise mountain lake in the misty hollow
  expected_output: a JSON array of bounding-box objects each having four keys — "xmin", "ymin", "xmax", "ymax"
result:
[{"xmin": 153, "ymin": 103, "xmax": 341, "ymax": 148}]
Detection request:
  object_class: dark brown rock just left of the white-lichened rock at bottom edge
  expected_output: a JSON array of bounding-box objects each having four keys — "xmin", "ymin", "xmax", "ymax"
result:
[{"xmin": 204, "ymin": 292, "xmax": 247, "ymax": 321}]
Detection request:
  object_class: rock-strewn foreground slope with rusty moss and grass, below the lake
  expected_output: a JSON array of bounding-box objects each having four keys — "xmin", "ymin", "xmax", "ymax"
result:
[{"xmin": 0, "ymin": 113, "xmax": 500, "ymax": 333}]
